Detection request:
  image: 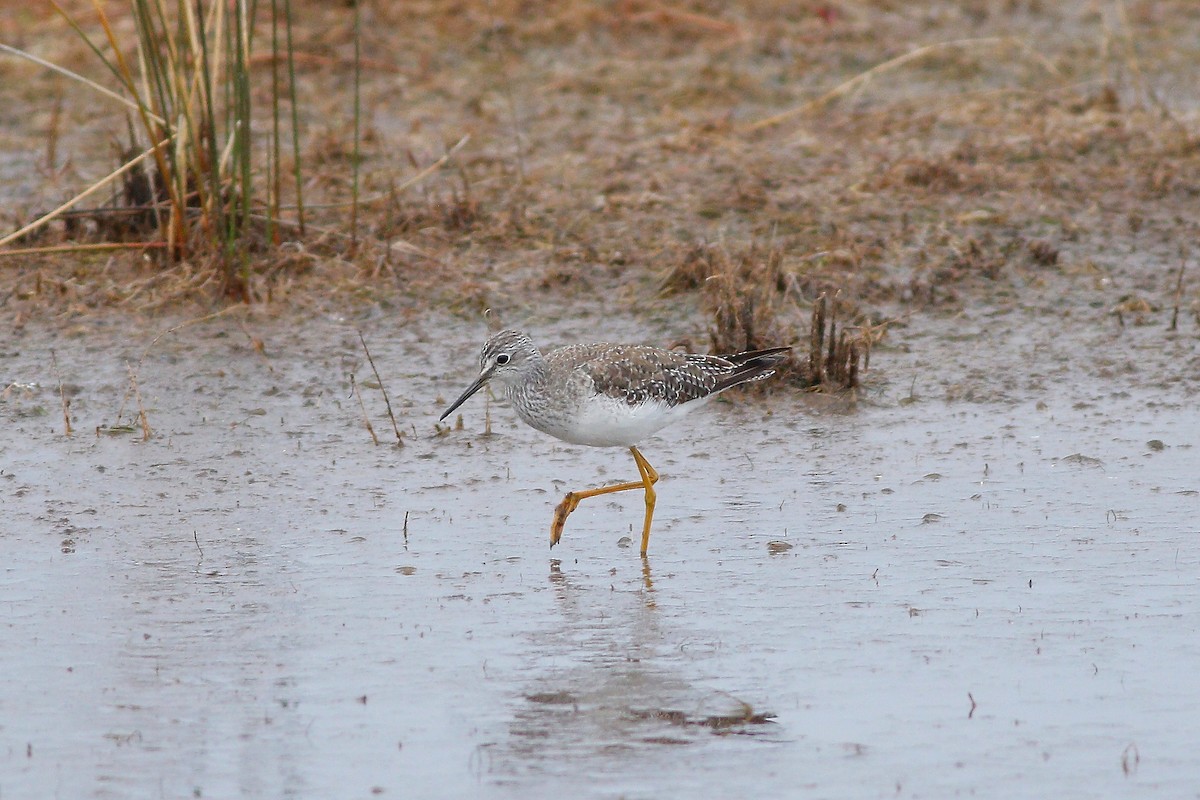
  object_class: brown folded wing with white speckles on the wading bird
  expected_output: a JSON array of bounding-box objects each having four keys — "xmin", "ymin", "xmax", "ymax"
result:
[{"xmin": 547, "ymin": 344, "xmax": 738, "ymax": 407}]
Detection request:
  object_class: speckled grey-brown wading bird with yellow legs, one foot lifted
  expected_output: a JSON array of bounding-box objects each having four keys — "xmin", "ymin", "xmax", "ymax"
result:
[{"xmin": 440, "ymin": 331, "xmax": 791, "ymax": 555}]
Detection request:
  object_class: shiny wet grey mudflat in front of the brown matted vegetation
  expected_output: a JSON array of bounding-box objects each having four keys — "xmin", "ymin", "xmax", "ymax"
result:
[{"xmin": 0, "ymin": 309, "xmax": 1200, "ymax": 798}]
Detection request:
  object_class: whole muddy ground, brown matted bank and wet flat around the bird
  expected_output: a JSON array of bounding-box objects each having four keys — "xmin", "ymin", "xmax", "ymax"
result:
[{"xmin": 0, "ymin": 2, "xmax": 1200, "ymax": 798}]
